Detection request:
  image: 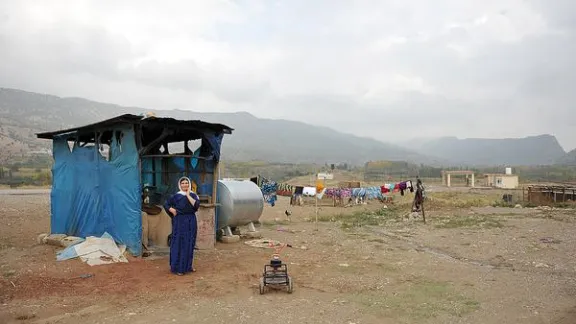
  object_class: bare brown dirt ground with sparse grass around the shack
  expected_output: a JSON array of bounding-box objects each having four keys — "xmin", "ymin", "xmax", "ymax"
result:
[{"xmin": 0, "ymin": 190, "xmax": 576, "ymax": 324}]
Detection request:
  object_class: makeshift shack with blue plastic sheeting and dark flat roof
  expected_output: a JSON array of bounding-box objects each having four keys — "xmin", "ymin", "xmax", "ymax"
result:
[{"xmin": 37, "ymin": 114, "xmax": 233, "ymax": 255}]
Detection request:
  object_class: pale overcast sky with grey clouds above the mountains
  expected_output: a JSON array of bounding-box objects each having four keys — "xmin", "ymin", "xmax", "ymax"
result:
[{"xmin": 0, "ymin": 0, "xmax": 576, "ymax": 150}]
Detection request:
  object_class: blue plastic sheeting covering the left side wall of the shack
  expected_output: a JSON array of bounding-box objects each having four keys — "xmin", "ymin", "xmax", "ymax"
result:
[{"xmin": 50, "ymin": 126, "xmax": 142, "ymax": 255}]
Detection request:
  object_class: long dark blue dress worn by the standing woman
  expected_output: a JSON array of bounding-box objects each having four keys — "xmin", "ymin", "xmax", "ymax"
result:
[{"xmin": 164, "ymin": 193, "xmax": 200, "ymax": 273}]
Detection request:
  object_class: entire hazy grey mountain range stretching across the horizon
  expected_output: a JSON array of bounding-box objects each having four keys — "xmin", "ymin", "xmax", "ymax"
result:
[{"xmin": 0, "ymin": 88, "xmax": 576, "ymax": 166}]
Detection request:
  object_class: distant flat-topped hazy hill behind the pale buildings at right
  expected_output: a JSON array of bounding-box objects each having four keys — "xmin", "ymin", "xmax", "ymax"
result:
[{"xmin": 404, "ymin": 135, "xmax": 566, "ymax": 166}]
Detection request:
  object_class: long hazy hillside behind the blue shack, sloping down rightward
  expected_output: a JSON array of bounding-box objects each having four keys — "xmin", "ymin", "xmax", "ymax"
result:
[{"xmin": 0, "ymin": 88, "xmax": 435, "ymax": 165}]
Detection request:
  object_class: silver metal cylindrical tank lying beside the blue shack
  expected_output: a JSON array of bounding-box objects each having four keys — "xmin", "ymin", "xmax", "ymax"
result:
[{"xmin": 216, "ymin": 180, "xmax": 264, "ymax": 229}]
